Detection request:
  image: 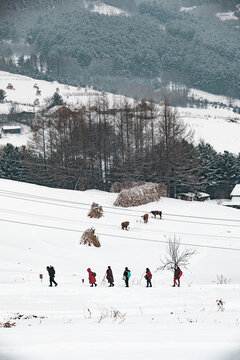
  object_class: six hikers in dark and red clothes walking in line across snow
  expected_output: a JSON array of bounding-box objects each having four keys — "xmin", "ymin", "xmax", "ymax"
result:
[{"xmin": 46, "ymin": 265, "xmax": 182, "ymax": 287}]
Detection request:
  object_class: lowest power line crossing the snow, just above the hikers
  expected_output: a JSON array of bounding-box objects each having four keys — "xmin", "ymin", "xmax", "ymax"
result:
[{"xmin": 0, "ymin": 218, "xmax": 240, "ymax": 251}]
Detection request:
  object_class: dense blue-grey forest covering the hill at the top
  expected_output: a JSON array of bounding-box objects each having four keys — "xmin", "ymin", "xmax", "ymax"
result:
[{"xmin": 0, "ymin": 0, "xmax": 240, "ymax": 97}]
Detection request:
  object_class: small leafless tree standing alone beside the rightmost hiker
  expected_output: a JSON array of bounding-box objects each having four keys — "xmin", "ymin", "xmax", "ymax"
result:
[{"xmin": 157, "ymin": 235, "xmax": 197, "ymax": 270}]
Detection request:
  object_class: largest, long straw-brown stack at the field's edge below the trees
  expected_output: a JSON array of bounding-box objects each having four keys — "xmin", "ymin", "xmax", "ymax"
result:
[{"xmin": 114, "ymin": 182, "xmax": 167, "ymax": 207}]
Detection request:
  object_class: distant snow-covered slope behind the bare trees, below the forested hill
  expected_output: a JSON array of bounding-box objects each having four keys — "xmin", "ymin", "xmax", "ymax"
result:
[{"xmin": 0, "ymin": 71, "xmax": 240, "ymax": 154}]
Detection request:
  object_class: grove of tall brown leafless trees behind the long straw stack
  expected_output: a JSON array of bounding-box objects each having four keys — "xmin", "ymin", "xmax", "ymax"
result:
[{"xmin": 27, "ymin": 94, "xmax": 200, "ymax": 196}]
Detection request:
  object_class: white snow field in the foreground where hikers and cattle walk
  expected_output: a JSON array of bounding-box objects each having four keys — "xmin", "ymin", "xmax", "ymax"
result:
[{"xmin": 0, "ymin": 179, "xmax": 240, "ymax": 360}]
